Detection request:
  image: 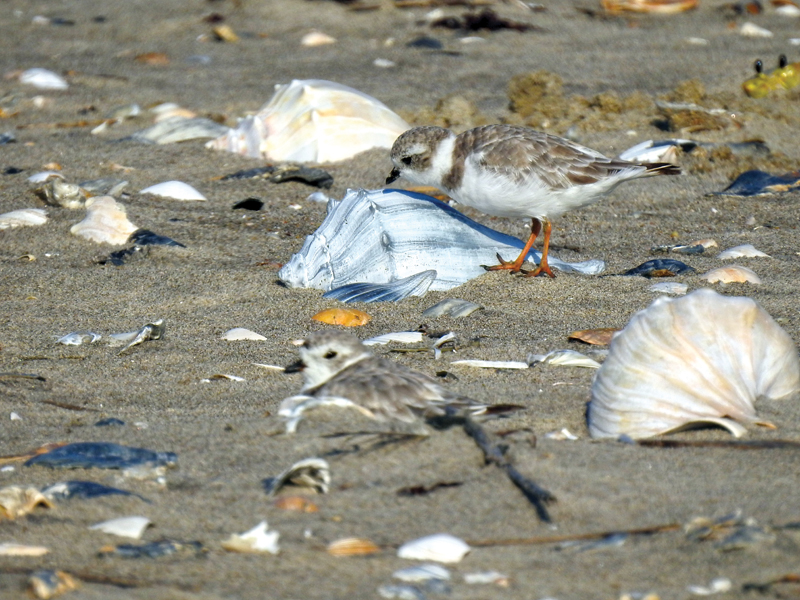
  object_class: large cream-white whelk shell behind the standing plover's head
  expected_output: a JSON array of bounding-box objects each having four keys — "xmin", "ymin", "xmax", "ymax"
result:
[{"xmin": 206, "ymin": 79, "xmax": 410, "ymax": 163}]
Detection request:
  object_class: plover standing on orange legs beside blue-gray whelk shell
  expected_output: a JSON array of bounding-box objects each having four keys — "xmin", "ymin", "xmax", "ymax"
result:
[{"xmin": 386, "ymin": 125, "xmax": 680, "ymax": 277}]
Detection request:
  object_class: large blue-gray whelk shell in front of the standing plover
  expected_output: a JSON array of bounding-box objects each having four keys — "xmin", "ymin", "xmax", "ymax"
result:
[{"xmin": 278, "ymin": 190, "xmax": 605, "ymax": 291}]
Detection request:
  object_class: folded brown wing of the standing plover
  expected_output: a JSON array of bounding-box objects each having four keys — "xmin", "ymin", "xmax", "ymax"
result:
[{"xmin": 456, "ymin": 125, "xmax": 639, "ymax": 189}]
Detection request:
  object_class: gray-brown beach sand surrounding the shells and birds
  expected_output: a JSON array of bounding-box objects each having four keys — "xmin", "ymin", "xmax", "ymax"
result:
[{"xmin": 0, "ymin": 0, "xmax": 800, "ymax": 599}]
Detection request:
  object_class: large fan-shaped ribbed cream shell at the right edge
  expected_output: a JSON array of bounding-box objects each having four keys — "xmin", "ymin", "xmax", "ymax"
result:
[{"xmin": 587, "ymin": 289, "xmax": 800, "ymax": 438}]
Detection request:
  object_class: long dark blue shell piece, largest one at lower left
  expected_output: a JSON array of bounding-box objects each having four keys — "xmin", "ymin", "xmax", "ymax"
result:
[{"xmin": 25, "ymin": 442, "xmax": 178, "ymax": 469}]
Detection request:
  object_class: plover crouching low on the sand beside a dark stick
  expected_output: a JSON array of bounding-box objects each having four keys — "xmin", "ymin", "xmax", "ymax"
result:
[{"xmin": 279, "ymin": 330, "xmax": 486, "ymax": 429}]
